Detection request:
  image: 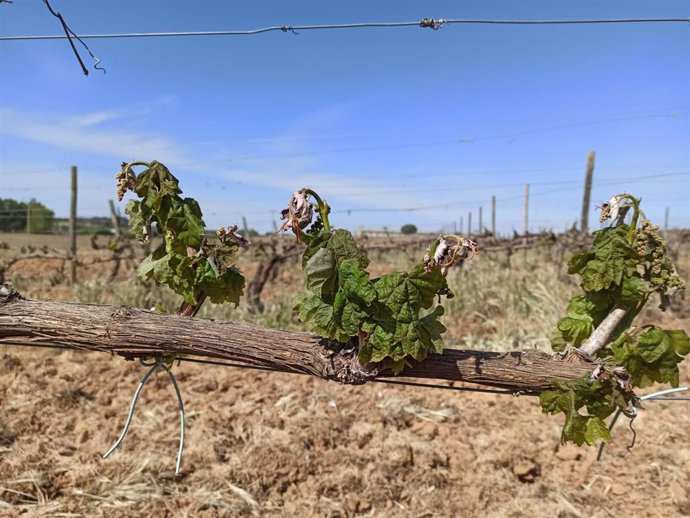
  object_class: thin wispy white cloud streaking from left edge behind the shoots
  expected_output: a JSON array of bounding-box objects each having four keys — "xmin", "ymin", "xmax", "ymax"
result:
[{"xmin": 0, "ymin": 103, "xmax": 440, "ymax": 230}]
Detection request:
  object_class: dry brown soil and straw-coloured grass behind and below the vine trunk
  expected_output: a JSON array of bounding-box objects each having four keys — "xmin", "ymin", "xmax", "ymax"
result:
[{"xmin": 0, "ymin": 236, "xmax": 690, "ymax": 518}]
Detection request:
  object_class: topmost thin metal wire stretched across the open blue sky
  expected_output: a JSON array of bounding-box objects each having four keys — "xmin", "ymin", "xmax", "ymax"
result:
[{"xmin": 0, "ymin": 18, "xmax": 690, "ymax": 41}]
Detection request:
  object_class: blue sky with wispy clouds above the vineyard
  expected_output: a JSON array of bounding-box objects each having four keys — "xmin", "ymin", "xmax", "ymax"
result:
[{"xmin": 0, "ymin": 0, "xmax": 690, "ymax": 232}]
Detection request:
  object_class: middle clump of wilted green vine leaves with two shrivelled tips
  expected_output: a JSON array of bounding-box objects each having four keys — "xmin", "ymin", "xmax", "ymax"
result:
[{"xmin": 281, "ymin": 188, "xmax": 477, "ymax": 373}]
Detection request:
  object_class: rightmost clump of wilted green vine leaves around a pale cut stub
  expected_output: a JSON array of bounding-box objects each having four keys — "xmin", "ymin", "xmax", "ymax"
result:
[{"xmin": 540, "ymin": 193, "xmax": 690, "ymax": 445}]
